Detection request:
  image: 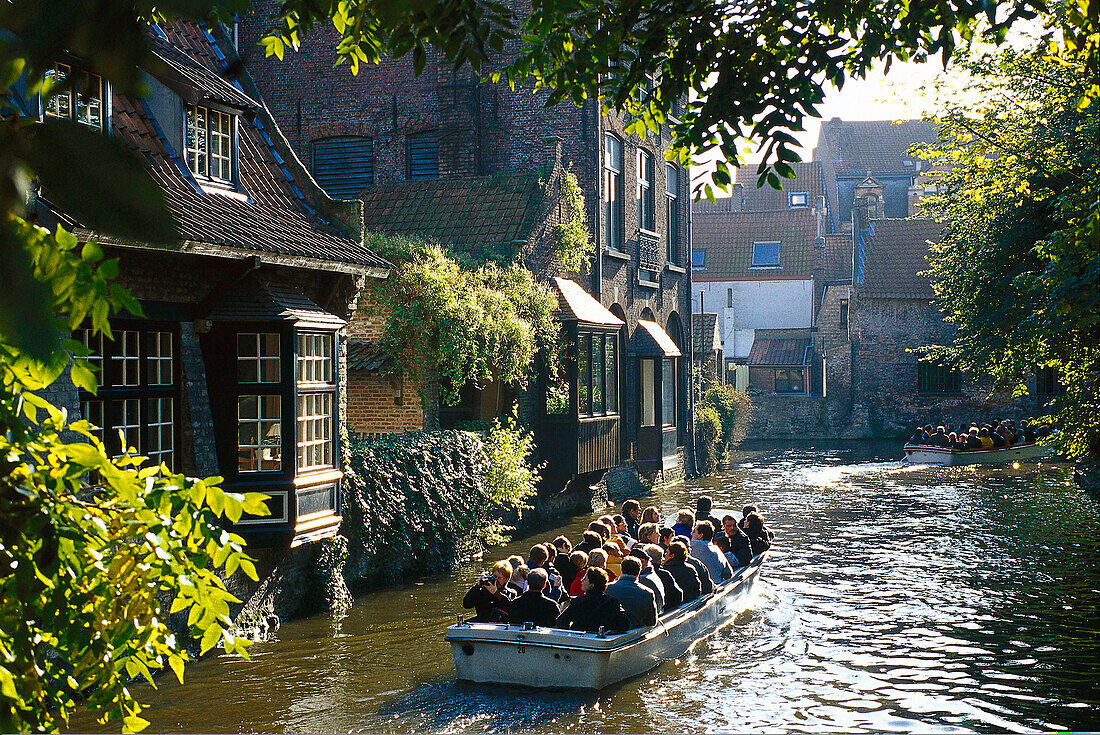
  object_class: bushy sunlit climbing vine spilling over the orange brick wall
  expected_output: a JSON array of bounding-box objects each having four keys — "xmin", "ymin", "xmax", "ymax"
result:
[{"xmin": 367, "ymin": 234, "xmax": 559, "ymax": 404}]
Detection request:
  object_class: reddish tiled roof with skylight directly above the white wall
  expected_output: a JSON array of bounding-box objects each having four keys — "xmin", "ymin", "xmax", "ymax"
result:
[{"xmin": 692, "ymin": 209, "xmax": 817, "ymax": 281}]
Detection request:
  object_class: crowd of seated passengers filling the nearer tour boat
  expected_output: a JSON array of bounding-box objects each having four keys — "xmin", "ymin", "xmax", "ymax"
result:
[{"xmin": 462, "ymin": 495, "xmax": 774, "ymax": 633}]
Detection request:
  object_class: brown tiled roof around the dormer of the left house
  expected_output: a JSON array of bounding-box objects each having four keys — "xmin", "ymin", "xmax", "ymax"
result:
[{"xmin": 53, "ymin": 22, "xmax": 392, "ymax": 272}]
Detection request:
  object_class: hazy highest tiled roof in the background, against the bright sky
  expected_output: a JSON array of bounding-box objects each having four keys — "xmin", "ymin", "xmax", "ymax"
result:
[{"xmin": 814, "ymin": 118, "xmax": 937, "ymax": 177}]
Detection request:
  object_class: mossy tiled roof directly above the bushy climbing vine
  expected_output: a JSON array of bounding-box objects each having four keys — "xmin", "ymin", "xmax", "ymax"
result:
[{"xmin": 362, "ymin": 174, "xmax": 543, "ymax": 251}]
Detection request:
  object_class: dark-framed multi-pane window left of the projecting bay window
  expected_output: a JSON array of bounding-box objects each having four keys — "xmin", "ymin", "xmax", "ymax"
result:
[{"xmin": 73, "ymin": 322, "xmax": 178, "ymax": 467}]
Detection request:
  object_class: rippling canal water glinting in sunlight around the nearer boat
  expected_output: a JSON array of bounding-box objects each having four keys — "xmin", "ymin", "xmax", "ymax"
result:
[{"xmin": 74, "ymin": 443, "xmax": 1100, "ymax": 733}]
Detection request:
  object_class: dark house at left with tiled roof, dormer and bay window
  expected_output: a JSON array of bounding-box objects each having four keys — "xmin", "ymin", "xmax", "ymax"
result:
[{"xmin": 24, "ymin": 23, "xmax": 391, "ymax": 549}]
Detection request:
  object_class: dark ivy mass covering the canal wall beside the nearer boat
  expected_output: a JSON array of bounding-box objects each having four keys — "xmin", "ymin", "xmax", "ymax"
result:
[{"xmin": 341, "ymin": 424, "xmax": 538, "ymax": 583}]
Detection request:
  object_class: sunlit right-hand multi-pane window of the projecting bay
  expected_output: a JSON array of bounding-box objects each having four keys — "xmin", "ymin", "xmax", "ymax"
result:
[{"xmin": 297, "ymin": 332, "xmax": 337, "ymax": 472}]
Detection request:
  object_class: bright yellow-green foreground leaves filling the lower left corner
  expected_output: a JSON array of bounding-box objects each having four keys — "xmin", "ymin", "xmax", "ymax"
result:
[{"xmin": 0, "ymin": 218, "xmax": 267, "ymax": 732}]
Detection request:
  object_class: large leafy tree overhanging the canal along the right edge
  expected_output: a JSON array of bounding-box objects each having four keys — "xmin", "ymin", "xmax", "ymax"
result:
[{"xmin": 920, "ymin": 45, "xmax": 1100, "ymax": 457}]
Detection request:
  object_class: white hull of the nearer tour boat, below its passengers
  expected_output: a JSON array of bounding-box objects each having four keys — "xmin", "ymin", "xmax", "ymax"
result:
[{"xmin": 447, "ymin": 551, "xmax": 768, "ymax": 689}]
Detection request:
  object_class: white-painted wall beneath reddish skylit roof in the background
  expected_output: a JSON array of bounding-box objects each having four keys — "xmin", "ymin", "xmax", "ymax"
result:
[{"xmin": 692, "ymin": 278, "xmax": 814, "ymax": 358}]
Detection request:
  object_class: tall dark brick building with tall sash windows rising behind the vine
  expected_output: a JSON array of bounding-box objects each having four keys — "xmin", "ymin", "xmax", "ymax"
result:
[{"xmin": 239, "ymin": 1, "xmax": 692, "ymax": 482}]
